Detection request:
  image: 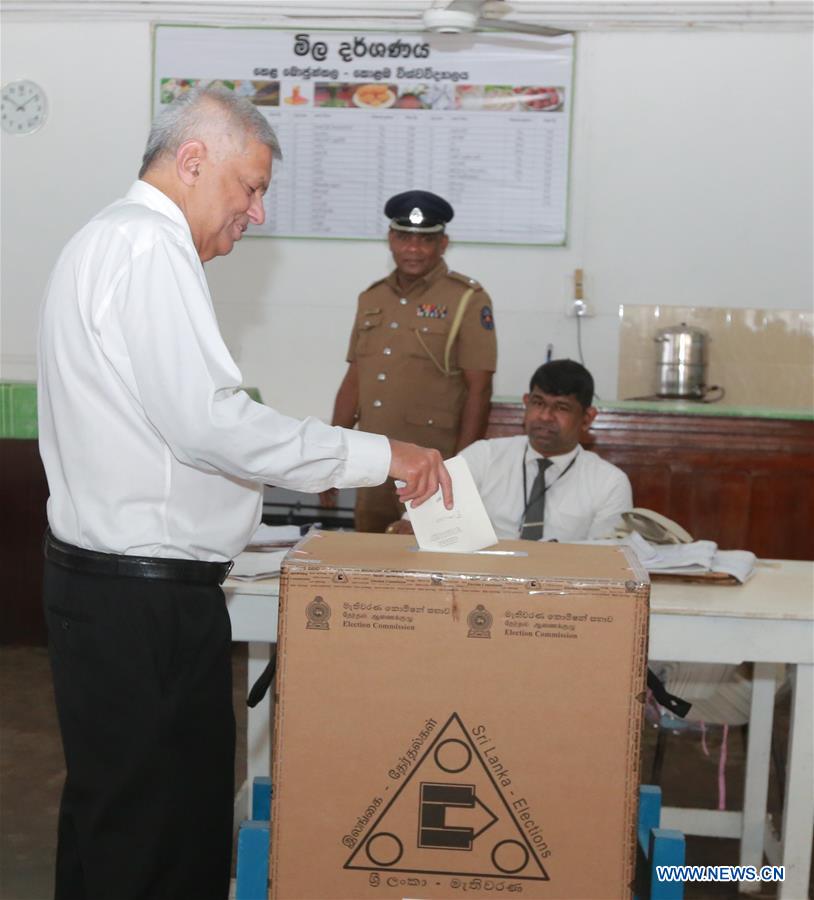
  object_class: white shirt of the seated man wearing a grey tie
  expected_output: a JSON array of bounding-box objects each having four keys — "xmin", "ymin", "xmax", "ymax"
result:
[{"xmin": 460, "ymin": 434, "xmax": 633, "ymax": 541}]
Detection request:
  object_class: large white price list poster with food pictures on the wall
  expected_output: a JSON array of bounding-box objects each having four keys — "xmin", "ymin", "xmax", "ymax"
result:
[{"xmin": 154, "ymin": 28, "xmax": 573, "ymax": 245}]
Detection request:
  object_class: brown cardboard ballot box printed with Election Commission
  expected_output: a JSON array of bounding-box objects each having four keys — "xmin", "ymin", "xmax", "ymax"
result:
[{"xmin": 270, "ymin": 533, "xmax": 650, "ymax": 900}]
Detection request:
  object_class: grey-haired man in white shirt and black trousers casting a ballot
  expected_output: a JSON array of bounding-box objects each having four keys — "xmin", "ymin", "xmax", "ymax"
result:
[{"xmin": 39, "ymin": 90, "xmax": 451, "ymax": 900}]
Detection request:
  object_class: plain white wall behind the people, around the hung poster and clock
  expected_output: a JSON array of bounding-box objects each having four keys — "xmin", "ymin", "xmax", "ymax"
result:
[{"xmin": 0, "ymin": 21, "xmax": 814, "ymax": 417}]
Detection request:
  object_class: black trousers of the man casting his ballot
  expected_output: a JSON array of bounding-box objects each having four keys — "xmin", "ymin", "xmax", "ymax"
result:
[{"xmin": 43, "ymin": 561, "xmax": 235, "ymax": 900}]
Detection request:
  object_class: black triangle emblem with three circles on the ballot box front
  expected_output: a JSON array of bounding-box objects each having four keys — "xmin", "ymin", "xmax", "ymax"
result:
[{"xmin": 344, "ymin": 713, "xmax": 549, "ymax": 881}]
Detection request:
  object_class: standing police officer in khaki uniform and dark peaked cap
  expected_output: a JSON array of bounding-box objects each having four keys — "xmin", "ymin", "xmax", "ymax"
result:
[{"xmin": 321, "ymin": 191, "xmax": 497, "ymax": 531}]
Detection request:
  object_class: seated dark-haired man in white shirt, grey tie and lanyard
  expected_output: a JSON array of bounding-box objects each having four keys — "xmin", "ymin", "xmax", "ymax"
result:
[{"xmin": 389, "ymin": 359, "xmax": 633, "ymax": 541}]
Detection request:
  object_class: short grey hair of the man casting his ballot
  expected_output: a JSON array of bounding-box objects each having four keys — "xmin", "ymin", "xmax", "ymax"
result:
[{"xmin": 138, "ymin": 87, "xmax": 283, "ymax": 178}]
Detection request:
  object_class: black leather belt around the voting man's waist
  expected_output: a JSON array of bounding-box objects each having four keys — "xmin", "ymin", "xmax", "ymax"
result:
[{"xmin": 45, "ymin": 529, "xmax": 234, "ymax": 584}]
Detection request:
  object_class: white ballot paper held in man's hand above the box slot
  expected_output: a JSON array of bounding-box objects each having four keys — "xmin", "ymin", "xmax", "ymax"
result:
[{"xmin": 407, "ymin": 456, "xmax": 497, "ymax": 553}]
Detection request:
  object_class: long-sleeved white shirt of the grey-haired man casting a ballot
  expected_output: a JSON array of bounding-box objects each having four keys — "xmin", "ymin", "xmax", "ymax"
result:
[{"xmin": 38, "ymin": 181, "xmax": 390, "ymax": 561}]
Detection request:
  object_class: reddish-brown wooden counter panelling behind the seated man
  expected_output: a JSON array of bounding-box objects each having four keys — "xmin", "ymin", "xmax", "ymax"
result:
[{"xmin": 487, "ymin": 403, "xmax": 814, "ymax": 559}]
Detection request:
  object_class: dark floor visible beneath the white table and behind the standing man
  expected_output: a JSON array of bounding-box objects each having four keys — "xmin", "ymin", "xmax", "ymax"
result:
[{"xmin": 0, "ymin": 645, "xmax": 808, "ymax": 900}]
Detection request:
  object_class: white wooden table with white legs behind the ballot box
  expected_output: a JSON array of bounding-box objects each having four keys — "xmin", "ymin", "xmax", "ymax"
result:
[{"xmin": 224, "ymin": 560, "xmax": 814, "ymax": 900}]
